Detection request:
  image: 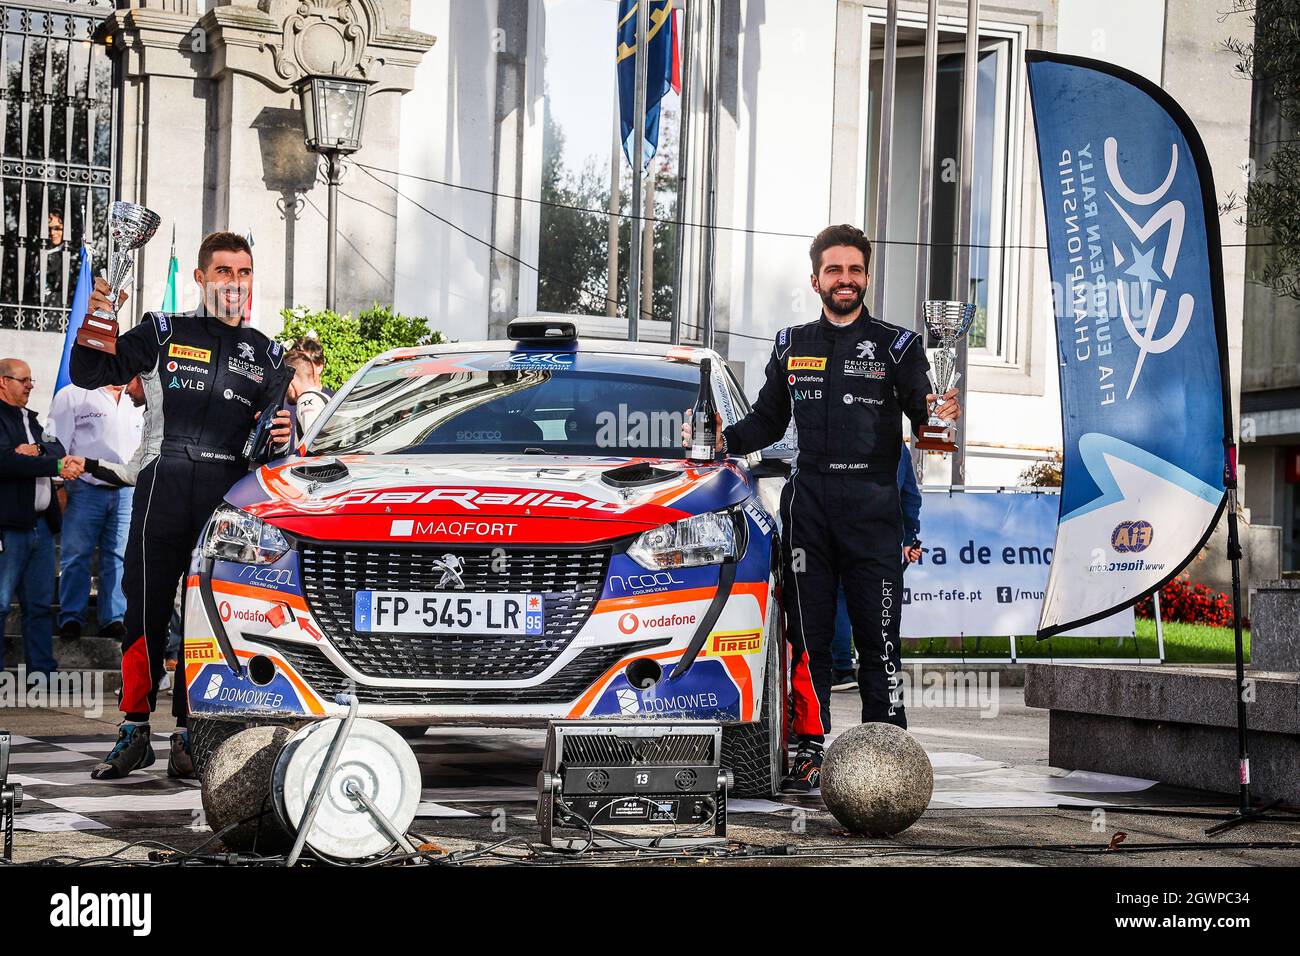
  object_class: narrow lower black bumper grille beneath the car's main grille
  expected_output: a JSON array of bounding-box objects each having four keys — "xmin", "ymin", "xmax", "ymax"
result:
[{"xmin": 263, "ymin": 635, "xmax": 668, "ymax": 704}]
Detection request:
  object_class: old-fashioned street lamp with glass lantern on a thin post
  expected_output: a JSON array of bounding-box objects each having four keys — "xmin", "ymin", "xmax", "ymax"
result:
[{"xmin": 294, "ymin": 75, "xmax": 373, "ymax": 311}]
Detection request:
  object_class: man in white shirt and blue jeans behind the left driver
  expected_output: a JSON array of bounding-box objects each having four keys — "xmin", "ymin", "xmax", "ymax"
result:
[{"xmin": 49, "ymin": 385, "xmax": 144, "ymax": 640}]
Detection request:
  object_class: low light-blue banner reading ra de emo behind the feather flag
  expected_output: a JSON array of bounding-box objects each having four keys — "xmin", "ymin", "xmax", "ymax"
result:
[{"xmin": 901, "ymin": 492, "xmax": 1134, "ymax": 637}]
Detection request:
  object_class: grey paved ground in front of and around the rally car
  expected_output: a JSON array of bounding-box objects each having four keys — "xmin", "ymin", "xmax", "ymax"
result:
[{"xmin": 0, "ymin": 687, "xmax": 1300, "ymax": 866}]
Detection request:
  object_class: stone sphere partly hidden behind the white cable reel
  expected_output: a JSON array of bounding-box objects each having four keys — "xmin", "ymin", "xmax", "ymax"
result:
[{"xmin": 199, "ymin": 727, "xmax": 293, "ymax": 853}]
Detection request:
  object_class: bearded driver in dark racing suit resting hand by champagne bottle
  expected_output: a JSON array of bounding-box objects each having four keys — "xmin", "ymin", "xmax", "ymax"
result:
[{"xmin": 686, "ymin": 225, "xmax": 961, "ymax": 791}]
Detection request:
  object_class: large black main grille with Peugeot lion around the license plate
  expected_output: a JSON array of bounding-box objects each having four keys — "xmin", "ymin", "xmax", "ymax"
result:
[{"xmin": 299, "ymin": 542, "xmax": 610, "ymax": 682}]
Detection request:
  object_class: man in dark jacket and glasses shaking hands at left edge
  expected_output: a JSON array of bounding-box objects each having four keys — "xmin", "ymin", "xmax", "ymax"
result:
[{"xmin": 0, "ymin": 359, "xmax": 86, "ymax": 674}]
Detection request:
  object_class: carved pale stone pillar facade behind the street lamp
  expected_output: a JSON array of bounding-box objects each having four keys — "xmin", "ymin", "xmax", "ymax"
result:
[{"xmin": 105, "ymin": 0, "xmax": 434, "ymax": 327}]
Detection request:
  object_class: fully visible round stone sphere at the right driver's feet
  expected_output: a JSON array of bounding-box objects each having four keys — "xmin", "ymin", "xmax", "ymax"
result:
[{"xmin": 822, "ymin": 723, "xmax": 935, "ymax": 836}]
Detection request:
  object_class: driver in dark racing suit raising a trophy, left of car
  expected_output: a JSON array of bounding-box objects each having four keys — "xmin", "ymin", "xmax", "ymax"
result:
[{"xmin": 72, "ymin": 233, "xmax": 293, "ymax": 779}]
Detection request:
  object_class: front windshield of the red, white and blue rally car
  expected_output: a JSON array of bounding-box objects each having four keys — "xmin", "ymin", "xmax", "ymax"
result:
[{"xmin": 309, "ymin": 351, "xmax": 699, "ymax": 458}]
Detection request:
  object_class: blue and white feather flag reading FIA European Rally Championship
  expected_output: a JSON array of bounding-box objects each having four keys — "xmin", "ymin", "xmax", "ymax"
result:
[{"xmin": 1026, "ymin": 51, "xmax": 1231, "ymax": 637}]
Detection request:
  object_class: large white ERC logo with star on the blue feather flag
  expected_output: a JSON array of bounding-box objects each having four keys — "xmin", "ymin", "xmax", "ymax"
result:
[{"xmin": 1105, "ymin": 137, "xmax": 1196, "ymax": 398}]
